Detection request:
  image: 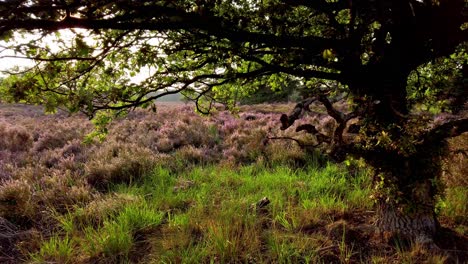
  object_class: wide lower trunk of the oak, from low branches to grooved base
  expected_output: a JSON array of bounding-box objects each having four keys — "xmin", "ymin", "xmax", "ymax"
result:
[{"xmin": 371, "ymin": 144, "xmax": 441, "ymax": 248}]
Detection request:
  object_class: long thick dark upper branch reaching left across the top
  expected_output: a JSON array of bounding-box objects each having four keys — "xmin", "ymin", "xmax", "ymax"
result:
[{"xmin": 0, "ymin": 5, "xmax": 343, "ymax": 50}]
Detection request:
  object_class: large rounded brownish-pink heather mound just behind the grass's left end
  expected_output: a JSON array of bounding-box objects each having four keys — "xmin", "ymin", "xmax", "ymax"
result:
[{"xmin": 85, "ymin": 141, "xmax": 155, "ymax": 188}]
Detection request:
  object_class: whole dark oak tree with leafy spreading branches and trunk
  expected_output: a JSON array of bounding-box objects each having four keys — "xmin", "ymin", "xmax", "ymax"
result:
[{"xmin": 0, "ymin": 0, "xmax": 468, "ymax": 243}]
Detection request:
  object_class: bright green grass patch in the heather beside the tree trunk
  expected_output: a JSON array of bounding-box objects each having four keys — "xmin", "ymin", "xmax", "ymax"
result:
[{"xmin": 32, "ymin": 164, "xmax": 372, "ymax": 263}]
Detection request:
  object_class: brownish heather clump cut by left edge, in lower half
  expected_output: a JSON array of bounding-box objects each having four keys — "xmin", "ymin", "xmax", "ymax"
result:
[{"xmin": 0, "ymin": 180, "xmax": 35, "ymax": 222}]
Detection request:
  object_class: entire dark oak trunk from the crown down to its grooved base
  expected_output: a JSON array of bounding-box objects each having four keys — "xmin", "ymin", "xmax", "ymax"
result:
[{"xmin": 350, "ymin": 60, "xmax": 443, "ymax": 248}]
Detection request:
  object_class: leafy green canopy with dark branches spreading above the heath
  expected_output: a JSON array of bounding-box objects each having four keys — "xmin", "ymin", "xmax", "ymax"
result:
[{"xmin": 0, "ymin": 0, "xmax": 466, "ymax": 115}]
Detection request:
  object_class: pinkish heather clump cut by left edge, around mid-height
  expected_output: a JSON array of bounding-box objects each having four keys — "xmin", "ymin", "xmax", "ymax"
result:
[{"xmin": 0, "ymin": 122, "xmax": 32, "ymax": 152}]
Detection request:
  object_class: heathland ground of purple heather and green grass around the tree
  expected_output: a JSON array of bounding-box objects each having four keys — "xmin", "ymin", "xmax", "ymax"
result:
[{"xmin": 0, "ymin": 104, "xmax": 468, "ymax": 263}]
